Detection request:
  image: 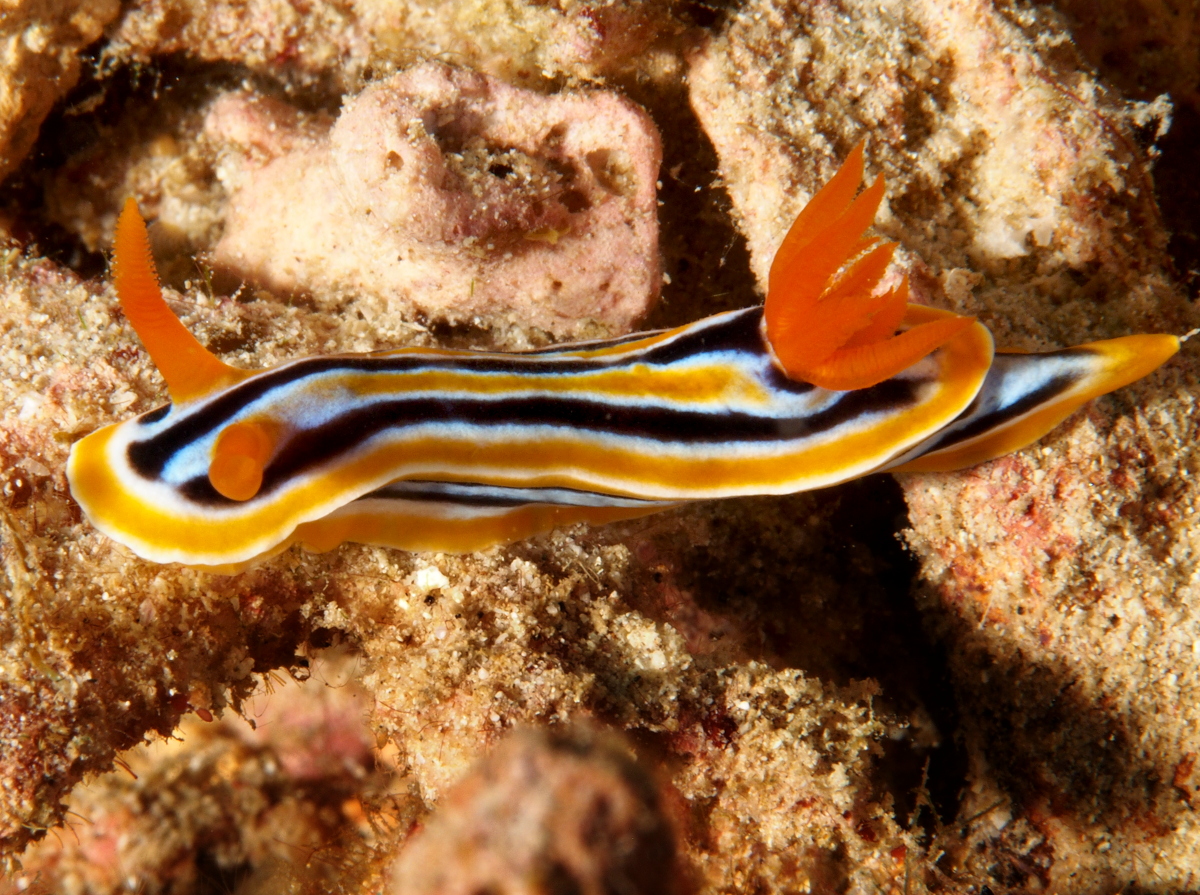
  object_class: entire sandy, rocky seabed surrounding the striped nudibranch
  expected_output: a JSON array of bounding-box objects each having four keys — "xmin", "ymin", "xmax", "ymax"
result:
[{"xmin": 0, "ymin": 0, "xmax": 1200, "ymax": 895}]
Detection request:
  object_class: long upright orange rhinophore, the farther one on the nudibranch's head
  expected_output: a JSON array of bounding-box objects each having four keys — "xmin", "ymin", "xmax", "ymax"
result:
[{"xmin": 114, "ymin": 197, "xmax": 247, "ymax": 403}]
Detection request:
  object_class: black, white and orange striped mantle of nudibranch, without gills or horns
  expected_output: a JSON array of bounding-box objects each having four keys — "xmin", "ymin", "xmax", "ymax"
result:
[{"xmin": 71, "ymin": 299, "xmax": 991, "ymax": 565}]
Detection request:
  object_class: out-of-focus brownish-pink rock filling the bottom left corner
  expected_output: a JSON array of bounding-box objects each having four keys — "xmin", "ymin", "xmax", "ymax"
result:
[{"xmin": 0, "ymin": 650, "xmax": 410, "ymax": 895}]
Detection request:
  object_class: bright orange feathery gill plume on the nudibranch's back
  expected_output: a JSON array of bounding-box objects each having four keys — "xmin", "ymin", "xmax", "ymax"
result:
[{"xmin": 764, "ymin": 143, "xmax": 974, "ymax": 391}]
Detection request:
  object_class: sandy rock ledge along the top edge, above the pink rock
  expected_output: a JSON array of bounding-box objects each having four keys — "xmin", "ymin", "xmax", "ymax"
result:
[{"xmin": 108, "ymin": 0, "xmax": 682, "ymax": 90}]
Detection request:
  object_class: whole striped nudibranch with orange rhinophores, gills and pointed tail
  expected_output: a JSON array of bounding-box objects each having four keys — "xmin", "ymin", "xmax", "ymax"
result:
[{"xmin": 67, "ymin": 145, "xmax": 1180, "ymax": 571}]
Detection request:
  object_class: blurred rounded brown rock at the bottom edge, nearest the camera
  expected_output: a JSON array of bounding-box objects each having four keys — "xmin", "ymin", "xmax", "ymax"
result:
[{"xmin": 391, "ymin": 728, "xmax": 683, "ymax": 895}]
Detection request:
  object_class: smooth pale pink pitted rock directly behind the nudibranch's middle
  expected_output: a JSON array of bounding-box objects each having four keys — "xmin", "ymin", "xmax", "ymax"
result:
[{"xmin": 205, "ymin": 64, "xmax": 661, "ymax": 336}]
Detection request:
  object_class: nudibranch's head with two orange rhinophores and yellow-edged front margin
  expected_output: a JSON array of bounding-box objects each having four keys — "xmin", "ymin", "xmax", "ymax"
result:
[{"xmin": 67, "ymin": 198, "xmax": 336, "ymax": 564}]
